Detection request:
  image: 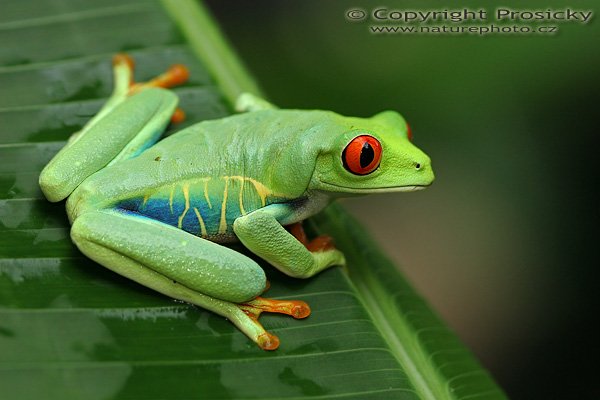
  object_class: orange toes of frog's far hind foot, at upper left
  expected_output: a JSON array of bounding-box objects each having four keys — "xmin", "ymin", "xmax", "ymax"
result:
[{"xmin": 113, "ymin": 53, "xmax": 190, "ymax": 123}]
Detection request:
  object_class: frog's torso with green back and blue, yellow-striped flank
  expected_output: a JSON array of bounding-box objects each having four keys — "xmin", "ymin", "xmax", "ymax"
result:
[{"xmin": 67, "ymin": 110, "xmax": 354, "ymax": 241}]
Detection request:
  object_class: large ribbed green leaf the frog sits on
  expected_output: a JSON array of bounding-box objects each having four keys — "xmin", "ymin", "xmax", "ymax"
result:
[{"xmin": 0, "ymin": 0, "xmax": 504, "ymax": 399}]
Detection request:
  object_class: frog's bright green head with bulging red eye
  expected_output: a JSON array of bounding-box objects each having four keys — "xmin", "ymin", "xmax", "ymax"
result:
[{"xmin": 310, "ymin": 111, "xmax": 434, "ymax": 194}]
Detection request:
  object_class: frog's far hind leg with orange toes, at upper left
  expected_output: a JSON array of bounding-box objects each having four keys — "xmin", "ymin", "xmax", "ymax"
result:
[{"xmin": 39, "ymin": 55, "xmax": 187, "ymax": 201}]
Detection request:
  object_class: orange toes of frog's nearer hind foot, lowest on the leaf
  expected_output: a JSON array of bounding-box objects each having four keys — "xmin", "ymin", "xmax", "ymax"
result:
[{"xmin": 238, "ymin": 297, "xmax": 310, "ymax": 350}]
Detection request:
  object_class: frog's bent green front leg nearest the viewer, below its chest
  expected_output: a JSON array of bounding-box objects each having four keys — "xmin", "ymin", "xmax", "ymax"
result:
[{"xmin": 233, "ymin": 204, "xmax": 346, "ymax": 278}]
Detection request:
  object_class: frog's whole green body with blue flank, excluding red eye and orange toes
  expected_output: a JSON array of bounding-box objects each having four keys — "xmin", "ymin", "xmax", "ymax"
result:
[{"xmin": 40, "ymin": 61, "xmax": 434, "ymax": 348}]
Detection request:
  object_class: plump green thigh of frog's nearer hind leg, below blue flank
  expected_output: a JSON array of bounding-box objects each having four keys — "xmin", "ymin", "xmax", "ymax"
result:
[{"xmin": 71, "ymin": 210, "xmax": 266, "ymax": 304}]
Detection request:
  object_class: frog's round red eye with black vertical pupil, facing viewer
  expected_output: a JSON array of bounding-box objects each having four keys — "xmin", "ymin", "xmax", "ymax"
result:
[{"xmin": 342, "ymin": 135, "xmax": 381, "ymax": 175}]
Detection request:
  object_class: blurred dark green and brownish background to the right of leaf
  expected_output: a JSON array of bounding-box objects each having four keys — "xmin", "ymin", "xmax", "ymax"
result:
[{"xmin": 208, "ymin": 0, "xmax": 600, "ymax": 399}]
